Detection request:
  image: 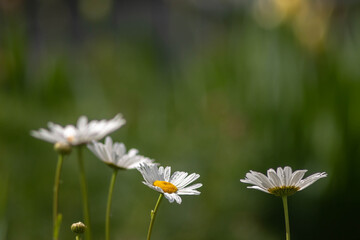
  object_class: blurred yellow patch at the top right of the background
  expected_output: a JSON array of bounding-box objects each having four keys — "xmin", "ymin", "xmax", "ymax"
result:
[{"xmin": 252, "ymin": 0, "xmax": 334, "ymax": 52}]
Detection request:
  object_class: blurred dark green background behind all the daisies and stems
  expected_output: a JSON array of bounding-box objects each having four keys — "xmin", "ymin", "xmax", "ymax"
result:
[{"xmin": 0, "ymin": 0, "xmax": 360, "ymax": 240}]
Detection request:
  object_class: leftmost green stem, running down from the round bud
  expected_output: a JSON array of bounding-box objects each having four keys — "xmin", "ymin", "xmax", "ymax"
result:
[{"xmin": 53, "ymin": 154, "xmax": 64, "ymax": 240}]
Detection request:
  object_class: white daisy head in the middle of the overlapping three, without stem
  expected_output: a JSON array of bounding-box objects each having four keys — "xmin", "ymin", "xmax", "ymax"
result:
[{"xmin": 88, "ymin": 137, "xmax": 154, "ymax": 169}]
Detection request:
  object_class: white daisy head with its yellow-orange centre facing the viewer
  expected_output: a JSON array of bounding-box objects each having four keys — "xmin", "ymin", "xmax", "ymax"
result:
[{"xmin": 138, "ymin": 164, "xmax": 202, "ymax": 204}]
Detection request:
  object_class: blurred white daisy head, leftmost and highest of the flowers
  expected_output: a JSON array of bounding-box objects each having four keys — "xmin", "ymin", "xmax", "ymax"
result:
[{"xmin": 31, "ymin": 114, "xmax": 125, "ymax": 146}]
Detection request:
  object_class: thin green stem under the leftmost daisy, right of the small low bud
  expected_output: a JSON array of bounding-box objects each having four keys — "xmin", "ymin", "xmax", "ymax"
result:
[{"xmin": 78, "ymin": 145, "xmax": 91, "ymax": 240}]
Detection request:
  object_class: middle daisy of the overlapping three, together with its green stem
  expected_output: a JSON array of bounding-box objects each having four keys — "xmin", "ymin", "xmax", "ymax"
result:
[{"xmin": 88, "ymin": 137, "xmax": 154, "ymax": 240}]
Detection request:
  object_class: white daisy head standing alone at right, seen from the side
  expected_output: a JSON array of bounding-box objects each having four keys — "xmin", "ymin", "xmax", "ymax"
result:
[{"xmin": 240, "ymin": 167, "xmax": 327, "ymax": 196}]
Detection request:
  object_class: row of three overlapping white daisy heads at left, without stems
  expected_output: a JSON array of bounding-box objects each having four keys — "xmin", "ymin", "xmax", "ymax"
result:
[{"xmin": 31, "ymin": 114, "xmax": 202, "ymax": 204}]
